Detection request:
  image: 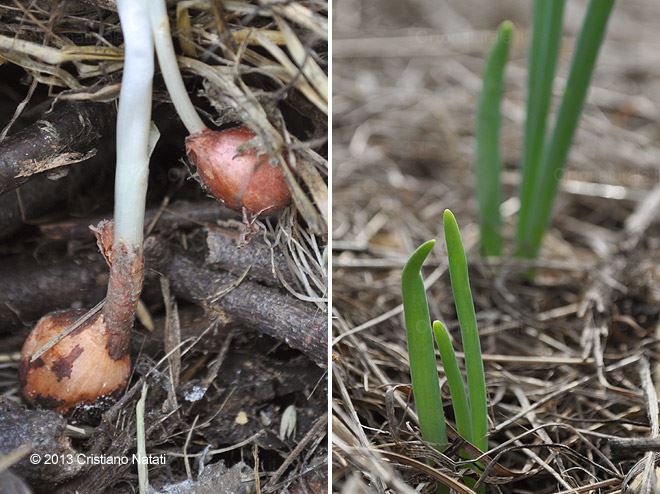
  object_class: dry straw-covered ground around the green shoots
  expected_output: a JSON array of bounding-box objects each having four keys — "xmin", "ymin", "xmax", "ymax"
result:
[{"xmin": 332, "ymin": 0, "xmax": 660, "ymax": 493}]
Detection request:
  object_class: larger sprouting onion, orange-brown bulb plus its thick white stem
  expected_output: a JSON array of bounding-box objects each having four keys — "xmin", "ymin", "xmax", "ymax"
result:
[{"xmin": 19, "ymin": 0, "xmax": 154, "ymax": 413}]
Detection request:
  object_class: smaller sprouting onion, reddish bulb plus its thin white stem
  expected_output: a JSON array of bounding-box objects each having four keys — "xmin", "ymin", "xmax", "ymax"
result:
[{"xmin": 148, "ymin": 0, "xmax": 291, "ymax": 215}]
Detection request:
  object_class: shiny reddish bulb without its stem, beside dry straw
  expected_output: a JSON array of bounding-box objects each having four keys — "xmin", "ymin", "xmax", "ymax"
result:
[{"xmin": 186, "ymin": 127, "xmax": 291, "ymax": 215}]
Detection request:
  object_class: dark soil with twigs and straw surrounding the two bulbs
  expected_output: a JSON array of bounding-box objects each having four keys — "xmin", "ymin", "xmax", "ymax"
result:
[{"xmin": 0, "ymin": 1, "xmax": 328, "ymax": 494}]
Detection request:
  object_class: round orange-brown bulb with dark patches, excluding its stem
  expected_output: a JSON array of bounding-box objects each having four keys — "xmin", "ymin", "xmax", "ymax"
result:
[{"xmin": 20, "ymin": 310, "xmax": 131, "ymax": 413}]
